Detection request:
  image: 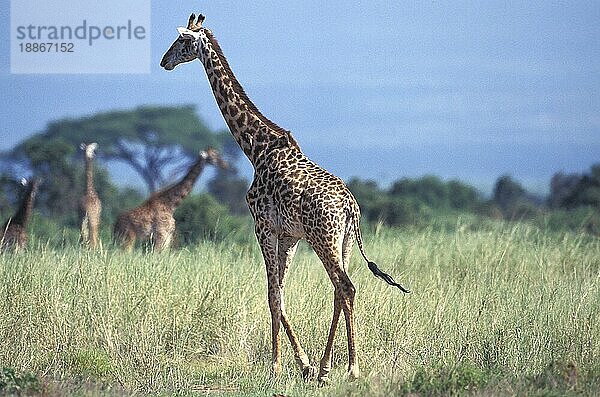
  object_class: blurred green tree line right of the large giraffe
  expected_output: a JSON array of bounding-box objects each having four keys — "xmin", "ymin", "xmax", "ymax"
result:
[{"xmin": 348, "ymin": 167, "xmax": 600, "ymax": 234}]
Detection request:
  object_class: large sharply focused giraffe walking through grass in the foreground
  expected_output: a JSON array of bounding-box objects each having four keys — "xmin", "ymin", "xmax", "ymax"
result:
[{"xmin": 160, "ymin": 14, "xmax": 409, "ymax": 383}]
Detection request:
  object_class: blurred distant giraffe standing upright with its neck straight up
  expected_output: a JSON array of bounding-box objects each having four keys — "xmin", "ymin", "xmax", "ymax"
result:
[{"xmin": 79, "ymin": 142, "xmax": 102, "ymax": 248}]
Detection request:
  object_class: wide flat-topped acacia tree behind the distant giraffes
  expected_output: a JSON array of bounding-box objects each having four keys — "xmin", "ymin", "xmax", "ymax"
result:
[{"xmin": 5, "ymin": 105, "xmax": 229, "ymax": 192}]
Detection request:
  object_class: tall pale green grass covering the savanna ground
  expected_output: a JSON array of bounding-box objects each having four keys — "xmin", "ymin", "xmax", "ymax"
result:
[{"xmin": 0, "ymin": 221, "xmax": 600, "ymax": 396}]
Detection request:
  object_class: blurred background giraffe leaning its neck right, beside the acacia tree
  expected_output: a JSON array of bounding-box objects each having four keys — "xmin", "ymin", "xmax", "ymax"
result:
[{"xmin": 113, "ymin": 148, "xmax": 227, "ymax": 250}]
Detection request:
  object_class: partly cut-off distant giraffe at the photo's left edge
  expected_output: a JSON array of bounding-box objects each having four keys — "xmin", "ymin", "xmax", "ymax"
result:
[{"xmin": 0, "ymin": 178, "xmax": 40, "ymax": 251}]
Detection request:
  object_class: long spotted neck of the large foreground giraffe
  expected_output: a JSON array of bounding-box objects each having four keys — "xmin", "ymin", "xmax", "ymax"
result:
[{"xmin": 198, "ymin": 29, "xmax": 300, "ymax": 166}]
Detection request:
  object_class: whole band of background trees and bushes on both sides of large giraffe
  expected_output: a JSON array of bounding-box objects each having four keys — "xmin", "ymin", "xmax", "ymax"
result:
[{"xmin": 0, "ymin": 105, "xmax": 600, "ymax": 244}]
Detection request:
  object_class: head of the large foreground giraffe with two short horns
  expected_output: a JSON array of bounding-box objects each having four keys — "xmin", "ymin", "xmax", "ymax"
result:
[{"xmin": 160, "ymin": 14, "xmax": 204, "ymax": 70}]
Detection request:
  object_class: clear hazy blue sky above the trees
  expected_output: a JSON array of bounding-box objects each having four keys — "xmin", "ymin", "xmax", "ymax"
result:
[{"xmin": 0, "ymin": 0, "xmax": 600, "ymax": 190}]
